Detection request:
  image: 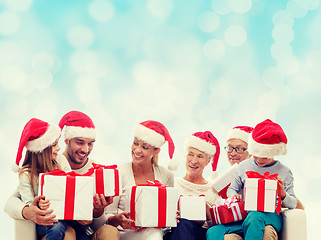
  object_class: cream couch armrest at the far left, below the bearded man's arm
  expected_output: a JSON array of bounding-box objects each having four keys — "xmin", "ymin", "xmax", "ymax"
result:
[{"xmin": 14, "ymin": 219, "xmax": 37, "ymax": 240}]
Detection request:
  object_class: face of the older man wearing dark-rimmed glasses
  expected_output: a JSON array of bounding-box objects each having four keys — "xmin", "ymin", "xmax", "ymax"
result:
[{"xmin": 227, "ymin": 138, "xmax": 250, "ymax": 165}]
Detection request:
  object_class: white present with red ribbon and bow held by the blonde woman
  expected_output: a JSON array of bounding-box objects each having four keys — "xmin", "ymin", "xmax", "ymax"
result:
[{"xmin": 125, "ymin": 180, "xmax": 178, "ymax": 227}]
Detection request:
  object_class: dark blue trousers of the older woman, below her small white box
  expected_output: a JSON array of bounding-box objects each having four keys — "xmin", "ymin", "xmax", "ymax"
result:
[{"xmin": 163, "ymin": 218, "xmax": 207, "ymax": 240}]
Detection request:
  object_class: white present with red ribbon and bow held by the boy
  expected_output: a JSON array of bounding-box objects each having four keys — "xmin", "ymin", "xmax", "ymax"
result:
[{"xmin": 244, "ymin": 171, "xmax": 281, "ymax": 214}]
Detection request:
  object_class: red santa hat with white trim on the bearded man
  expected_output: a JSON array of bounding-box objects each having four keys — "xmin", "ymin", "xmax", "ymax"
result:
[{"xmin": 59, "ymin": 111, "xmax": 96, "ymax": 139}]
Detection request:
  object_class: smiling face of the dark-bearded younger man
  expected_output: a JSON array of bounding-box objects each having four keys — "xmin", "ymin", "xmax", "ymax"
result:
[{"xmin": 65, "ymin": 137, "xmax": 95, "ymax": 169}]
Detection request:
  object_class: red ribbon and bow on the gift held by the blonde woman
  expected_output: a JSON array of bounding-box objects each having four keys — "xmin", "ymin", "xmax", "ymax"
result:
[{"xmin": 130, "ymin": 180, "xmax": 167, "ymax": 227}]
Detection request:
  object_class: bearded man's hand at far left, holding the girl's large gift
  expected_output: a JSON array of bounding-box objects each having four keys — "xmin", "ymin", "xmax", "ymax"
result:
[{"xmin": 22, "ymin": 196, "xmax": 58, "ymax": 226}]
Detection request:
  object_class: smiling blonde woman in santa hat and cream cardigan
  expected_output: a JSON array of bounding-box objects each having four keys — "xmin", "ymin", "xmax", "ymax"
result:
[{"xmin": 98, "ymin": 120, "xmax": 175, "ymax": 240}]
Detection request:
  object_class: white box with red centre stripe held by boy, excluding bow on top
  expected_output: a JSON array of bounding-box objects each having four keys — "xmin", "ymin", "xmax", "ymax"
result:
[{"xmin": 244, "ymin": 178, "xmax": 278, "ymax": 212}]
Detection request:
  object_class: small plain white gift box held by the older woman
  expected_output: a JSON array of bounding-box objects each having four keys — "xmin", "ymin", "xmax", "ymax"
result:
[{"xmin": 178, "ymin": 195, "xmax": 206, "ymax": 221}]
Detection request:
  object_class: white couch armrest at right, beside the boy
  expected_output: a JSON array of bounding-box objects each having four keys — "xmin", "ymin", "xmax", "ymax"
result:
[{"xmin": 280, "ymin": 209, "xmax": 307, "ymax": 240}]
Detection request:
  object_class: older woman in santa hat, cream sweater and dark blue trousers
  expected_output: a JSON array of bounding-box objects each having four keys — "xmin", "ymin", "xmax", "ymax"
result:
[{"xmin": 164, "ymin": 131, "xmax": 220, "ymax": 240}]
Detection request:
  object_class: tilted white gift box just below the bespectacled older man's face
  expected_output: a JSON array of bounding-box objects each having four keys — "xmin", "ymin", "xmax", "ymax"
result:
[{"xmin": 213, "ymin": 163, "xmax": 238, "ymax": 198}]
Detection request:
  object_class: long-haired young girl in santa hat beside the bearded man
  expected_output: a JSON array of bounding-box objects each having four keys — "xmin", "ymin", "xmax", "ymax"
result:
[{"xmin": 15, "ymin": 118, "xmax": 77, "ymax": 240}]
